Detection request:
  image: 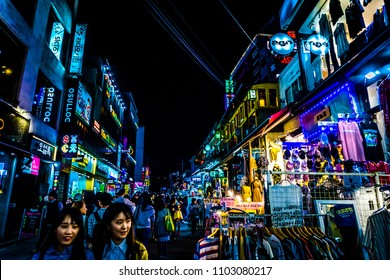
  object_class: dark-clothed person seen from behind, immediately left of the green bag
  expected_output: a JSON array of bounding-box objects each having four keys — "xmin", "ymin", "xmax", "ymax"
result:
[{"xmin": 154, "ymin": 195, "xmax": 170, "ymax": 260}]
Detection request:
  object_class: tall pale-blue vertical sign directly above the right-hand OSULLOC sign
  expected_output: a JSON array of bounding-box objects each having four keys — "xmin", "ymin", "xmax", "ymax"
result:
[{"xmin": 69, "ymin": 24, "xmax": 87, "ymax": 74}]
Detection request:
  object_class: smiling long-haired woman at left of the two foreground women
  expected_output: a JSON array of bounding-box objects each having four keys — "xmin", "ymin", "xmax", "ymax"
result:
[{"xmin": 32, "ymin": 207, "xmax": 95, "ymax": 260}]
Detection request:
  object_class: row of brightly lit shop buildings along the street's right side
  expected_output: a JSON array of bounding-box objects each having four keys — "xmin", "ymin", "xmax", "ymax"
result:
[{"xmin": 194, "ymin": 0, "xmax": 390, "ymax": 259}]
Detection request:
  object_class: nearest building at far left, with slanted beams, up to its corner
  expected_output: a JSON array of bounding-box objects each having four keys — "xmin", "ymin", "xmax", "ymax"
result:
[{"xmin": 0, "ymin": 0, "xmax": 77, "ymax": 243}]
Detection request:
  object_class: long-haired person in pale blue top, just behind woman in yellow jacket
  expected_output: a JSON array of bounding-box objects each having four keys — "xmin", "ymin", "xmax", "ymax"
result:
[{"xmin": 134, "ymin": 192, "xmax": 155, "ymax": 252}]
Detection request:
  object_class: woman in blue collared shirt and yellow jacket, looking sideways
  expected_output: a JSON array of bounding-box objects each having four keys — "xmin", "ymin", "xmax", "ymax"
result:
[{"xmin": 92, "ymin": 203, "xmax": 149, "ymax": 260}]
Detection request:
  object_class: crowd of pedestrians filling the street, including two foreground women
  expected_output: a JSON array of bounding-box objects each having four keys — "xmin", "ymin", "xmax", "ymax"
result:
[{"xmin": 33, "ymin": 188, "xmax": 201, "ymax": 260}]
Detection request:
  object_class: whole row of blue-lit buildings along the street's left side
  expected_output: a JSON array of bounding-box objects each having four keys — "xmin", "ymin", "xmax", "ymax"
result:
[{"xmin": 0, "ymin": 0, "xmax": 143, "ymax": 241}]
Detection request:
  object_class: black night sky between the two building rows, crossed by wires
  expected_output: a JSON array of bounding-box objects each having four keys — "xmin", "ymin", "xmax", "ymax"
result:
[{"xmin": 77, "ymin": 0, "xmax": 283, "ymax": 176}]
